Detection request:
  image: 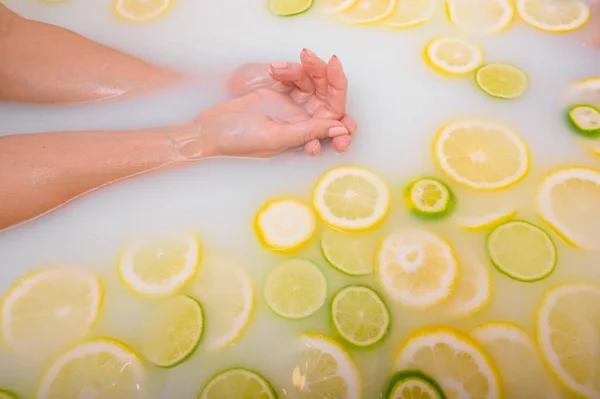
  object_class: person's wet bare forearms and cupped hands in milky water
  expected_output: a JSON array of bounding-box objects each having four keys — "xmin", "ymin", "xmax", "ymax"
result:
[{"xmin": 0, "ymin": 5, "xmax": 357, "ymax": 229}]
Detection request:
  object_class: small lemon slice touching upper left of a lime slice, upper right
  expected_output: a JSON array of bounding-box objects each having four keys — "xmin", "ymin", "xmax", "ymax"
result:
[{"xmin": 425, "ymin": 36, "xmax": 483, "ymax": 75}]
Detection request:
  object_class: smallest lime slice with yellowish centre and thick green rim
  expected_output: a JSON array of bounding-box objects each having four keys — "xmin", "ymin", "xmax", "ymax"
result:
[{"xmin": 404, "ymin": 178, "xmax": 453, "ymax": 217}]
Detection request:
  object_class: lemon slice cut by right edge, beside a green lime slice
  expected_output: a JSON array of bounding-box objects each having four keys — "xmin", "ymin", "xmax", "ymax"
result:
[{"xmin": 537, "ymin": 167, "xmax": 600, "ymax": 249}]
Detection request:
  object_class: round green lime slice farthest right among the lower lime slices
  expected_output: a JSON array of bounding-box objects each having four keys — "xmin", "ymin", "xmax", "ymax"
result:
[{"xmin": 487, "ymin": 221, "xmax": 557, "ymax": 282}]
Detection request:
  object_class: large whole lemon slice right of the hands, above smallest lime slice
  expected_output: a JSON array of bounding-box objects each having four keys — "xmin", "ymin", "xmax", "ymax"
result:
[{"xmin": 433, "ymin": 120, "xmax": 529, "ymax": 190}]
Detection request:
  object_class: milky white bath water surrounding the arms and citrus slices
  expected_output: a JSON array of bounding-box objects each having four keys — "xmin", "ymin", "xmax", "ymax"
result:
[{"xmin": 0, "ymin": 0, "xmax": 600, "ymax": 399}]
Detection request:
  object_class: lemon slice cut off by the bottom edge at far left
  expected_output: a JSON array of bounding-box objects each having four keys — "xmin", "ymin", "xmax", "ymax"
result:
[{"xmin": 37, "ymin": 339, "xmax": 145, "ymax": 399}]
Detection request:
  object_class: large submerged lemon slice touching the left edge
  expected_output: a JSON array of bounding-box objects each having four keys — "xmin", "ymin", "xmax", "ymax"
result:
[{"xmin": 0, "ymin": 269, "xmax": 103, "ymax": 354}]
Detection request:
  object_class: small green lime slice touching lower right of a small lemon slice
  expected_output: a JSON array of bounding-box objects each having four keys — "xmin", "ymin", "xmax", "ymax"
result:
[{"xmin": 475, "ymin": 63, "xmax": 529, "ymax": 100}]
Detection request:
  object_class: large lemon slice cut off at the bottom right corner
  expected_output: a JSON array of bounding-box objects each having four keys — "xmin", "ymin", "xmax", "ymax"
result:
[{"xmin": 536, "ymin": 284, "xmax": 600, "ymax": 398}]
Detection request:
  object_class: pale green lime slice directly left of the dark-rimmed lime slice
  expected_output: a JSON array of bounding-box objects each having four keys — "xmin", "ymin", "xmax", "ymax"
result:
[{"xmin": 265, "ymin": 259, "xmax": 327, "ymax": 319}]
